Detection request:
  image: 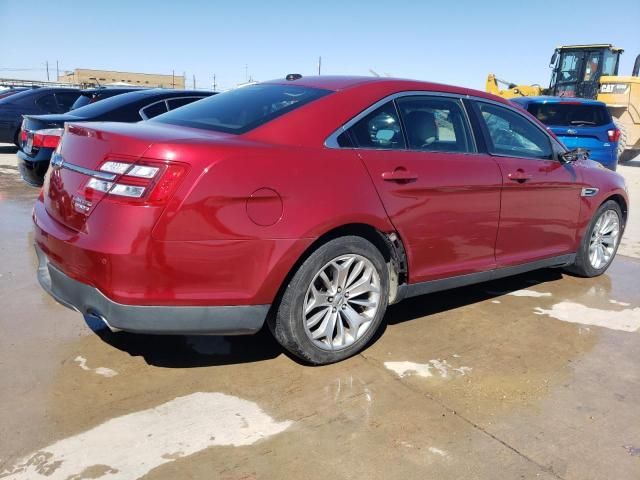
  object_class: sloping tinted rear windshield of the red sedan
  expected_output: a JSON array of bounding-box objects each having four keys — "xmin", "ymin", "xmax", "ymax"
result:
[{"xmin": 150, "ymin": 85, "xmax": 331, "ymax": 134}]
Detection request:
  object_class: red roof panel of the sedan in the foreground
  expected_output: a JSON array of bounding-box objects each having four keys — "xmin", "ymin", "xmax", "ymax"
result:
[{"xmin": 261, "ymin": 75, "xmax": 508, "ymax": 104}]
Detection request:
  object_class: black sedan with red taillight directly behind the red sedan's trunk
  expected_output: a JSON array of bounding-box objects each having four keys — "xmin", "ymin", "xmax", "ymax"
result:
[{"xmin": 18, "ymin": 88, "xmax": 213, "ymax": 187}]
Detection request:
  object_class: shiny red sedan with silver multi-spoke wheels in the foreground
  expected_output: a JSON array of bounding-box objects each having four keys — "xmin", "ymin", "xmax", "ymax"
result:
[{"xmin": 33, "ymin": 75, "xmax": 628, "ymax": 364}]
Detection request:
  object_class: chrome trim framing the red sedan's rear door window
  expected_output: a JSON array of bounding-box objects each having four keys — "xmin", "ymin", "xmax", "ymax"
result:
[{"xmin": 324, "ymin": 90, "xmax": 479, "ymax": 155}]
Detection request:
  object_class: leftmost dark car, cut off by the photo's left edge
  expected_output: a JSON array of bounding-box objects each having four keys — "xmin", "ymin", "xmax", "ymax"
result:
[{"xmin": 0, "ymin": 87, "xmax": 80, "ymax": 146}]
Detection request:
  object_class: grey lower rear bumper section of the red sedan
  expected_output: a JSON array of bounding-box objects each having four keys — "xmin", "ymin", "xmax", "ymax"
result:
[{"xmin": 36, "ymin": 246, "xmax": 270, "ymax": 335}]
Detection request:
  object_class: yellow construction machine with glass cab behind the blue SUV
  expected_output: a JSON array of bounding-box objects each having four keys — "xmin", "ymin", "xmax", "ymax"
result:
[{"xmin": 486, "ymin": 44, "xmax": 640, "ymax": 161}]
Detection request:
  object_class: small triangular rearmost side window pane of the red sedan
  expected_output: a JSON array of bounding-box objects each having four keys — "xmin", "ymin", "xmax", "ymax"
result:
[{"xmin": 349, "ymin": 100, "xmax": 406, "ymax": 150}]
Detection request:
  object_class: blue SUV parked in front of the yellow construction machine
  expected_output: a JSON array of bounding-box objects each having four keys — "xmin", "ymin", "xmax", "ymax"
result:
[{"xmin": 511, "ymin": 97, "xmax": 620, "ymax": 170}]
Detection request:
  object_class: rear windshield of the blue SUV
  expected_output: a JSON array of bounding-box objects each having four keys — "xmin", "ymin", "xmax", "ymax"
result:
[{"xmin": 527, "ymin": 103, "xmax": 612, "ymax": 127}]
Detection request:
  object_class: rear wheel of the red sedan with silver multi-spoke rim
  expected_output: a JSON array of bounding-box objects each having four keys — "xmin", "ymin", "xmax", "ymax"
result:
[{"xmin": 269, "ymin": 236, "xmax": 389, "ymax": 365}]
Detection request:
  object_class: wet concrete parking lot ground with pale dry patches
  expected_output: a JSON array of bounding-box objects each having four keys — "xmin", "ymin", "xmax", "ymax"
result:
[{"xmin": 0, "ymin": 147, "xmax": 640, "ymax": 480}]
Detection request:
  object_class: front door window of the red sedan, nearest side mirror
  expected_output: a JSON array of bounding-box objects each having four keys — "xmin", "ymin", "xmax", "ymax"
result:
[{"xmin": 476, "ymin": 102, "xmax": 553, "ymax": 159}]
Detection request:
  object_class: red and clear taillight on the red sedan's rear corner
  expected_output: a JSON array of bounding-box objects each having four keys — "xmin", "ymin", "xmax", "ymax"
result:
[{"xmin": 86, "ymin": 160, "xmax": 187, "ymax": 203}]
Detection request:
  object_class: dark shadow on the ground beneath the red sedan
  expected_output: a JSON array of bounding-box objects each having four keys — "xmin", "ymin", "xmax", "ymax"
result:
[{"xmin": 90, "ymin": 269, "xmax": 562, "ymax": 368}]
